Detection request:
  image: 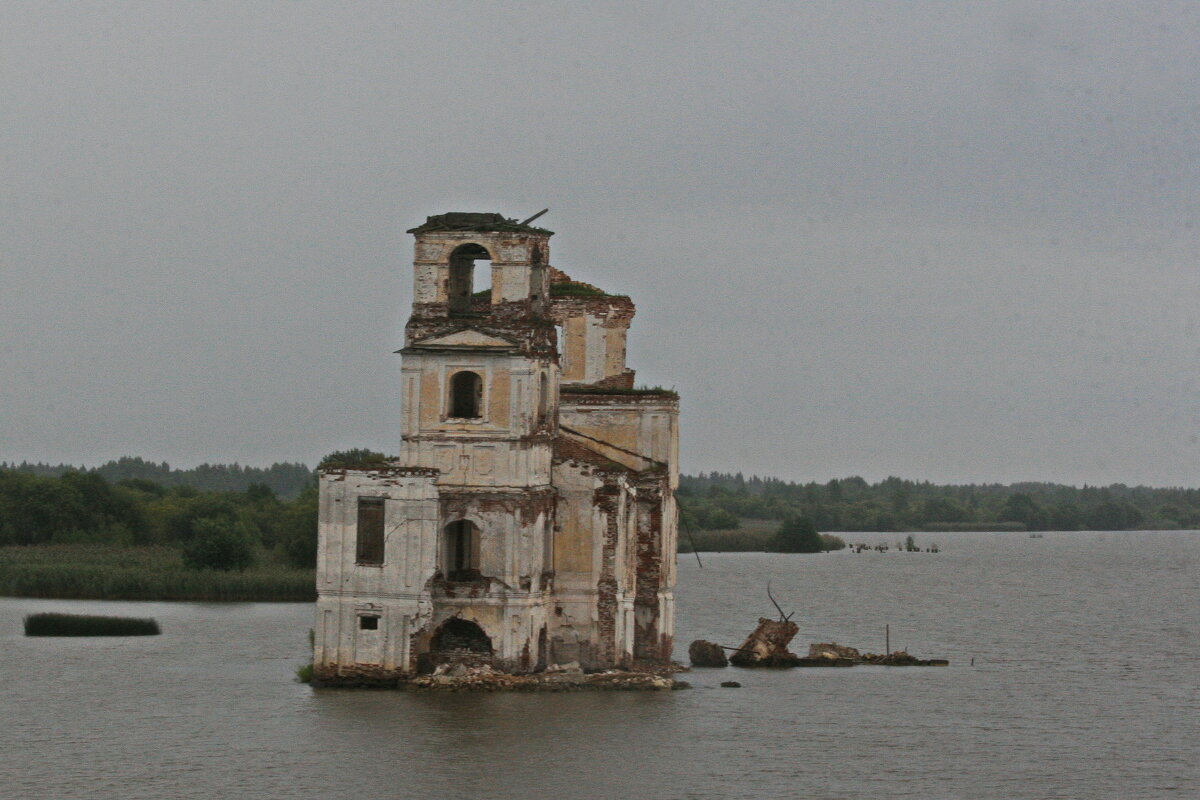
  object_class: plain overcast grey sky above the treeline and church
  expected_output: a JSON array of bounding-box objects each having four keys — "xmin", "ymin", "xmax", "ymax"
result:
[{"xmin": 0, "ymin": 1, "xmax": 1200, "ymax": 486}]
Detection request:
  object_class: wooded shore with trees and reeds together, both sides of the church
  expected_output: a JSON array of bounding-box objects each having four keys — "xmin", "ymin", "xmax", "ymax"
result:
[{"xmin": 0, "ymin": 450, "xmax": 1200, "ymax": 602}]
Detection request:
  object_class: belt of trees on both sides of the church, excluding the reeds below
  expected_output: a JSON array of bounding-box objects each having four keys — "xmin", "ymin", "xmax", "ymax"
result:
[{"xmin": 0, "ymin": 462, "xmax": 1200, "ymax": 556}]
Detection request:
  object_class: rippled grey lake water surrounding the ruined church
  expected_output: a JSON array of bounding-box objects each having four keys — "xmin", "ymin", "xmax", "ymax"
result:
[{"xmin": 0, "ymin": 531, "xmax": 1200, "ymax": 800}]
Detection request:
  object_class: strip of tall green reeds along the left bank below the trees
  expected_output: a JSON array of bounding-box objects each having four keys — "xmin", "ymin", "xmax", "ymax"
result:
[{"xmin": 0, "ymin": 545, "xmax": 317, "ymax": 602}]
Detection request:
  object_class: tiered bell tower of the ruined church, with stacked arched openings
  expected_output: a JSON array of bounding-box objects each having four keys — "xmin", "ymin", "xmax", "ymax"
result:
[{"xmin": 400, "ymin": 212, "xmax": 559, "ymax": 669}]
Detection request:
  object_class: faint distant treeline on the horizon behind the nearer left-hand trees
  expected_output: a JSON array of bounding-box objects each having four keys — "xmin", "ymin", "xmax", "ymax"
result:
[{"xmin": 0, "ymin": 456, "xmax": 313, "ymax": 499}]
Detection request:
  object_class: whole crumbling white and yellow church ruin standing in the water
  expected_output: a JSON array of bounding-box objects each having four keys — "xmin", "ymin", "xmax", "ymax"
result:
[{"xmin": 313, "ymin": 213, "xmax": 679, "ymax": 682}]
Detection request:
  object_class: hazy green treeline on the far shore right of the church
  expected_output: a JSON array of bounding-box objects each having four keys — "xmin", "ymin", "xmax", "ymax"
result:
[{"xmin": 678, "ymin": 473, "xmax": 1200, "ymax": 531}]
